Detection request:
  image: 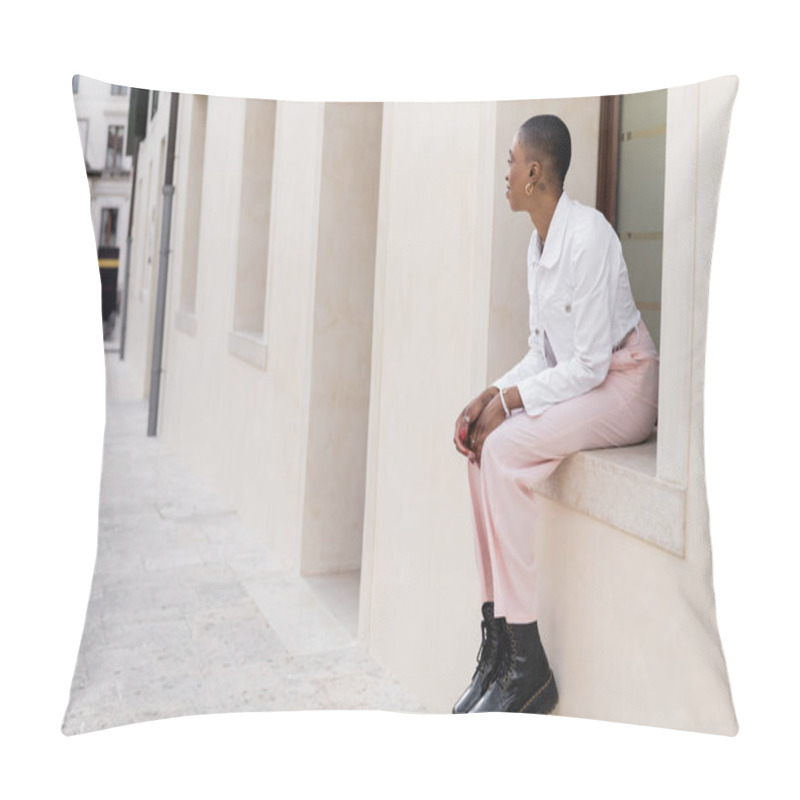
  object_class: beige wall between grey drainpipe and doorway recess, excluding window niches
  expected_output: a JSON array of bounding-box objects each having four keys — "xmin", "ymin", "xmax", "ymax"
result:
[{"xmin": 160, "ymin": 97, "xmax": 323, "ymax": 568}]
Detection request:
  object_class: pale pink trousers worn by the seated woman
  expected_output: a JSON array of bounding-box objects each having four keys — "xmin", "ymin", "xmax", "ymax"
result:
[{"xmin": 468, "ymin": 322, "xmax": 658, "ymax": 624}]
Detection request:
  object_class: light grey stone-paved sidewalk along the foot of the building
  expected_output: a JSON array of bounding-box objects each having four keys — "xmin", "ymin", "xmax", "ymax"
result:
[{"xmin": 62, "ymin": 346, "xmax": 424, "ymax": 734}]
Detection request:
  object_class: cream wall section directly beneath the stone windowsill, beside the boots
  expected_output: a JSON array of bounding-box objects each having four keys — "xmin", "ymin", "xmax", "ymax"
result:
[{"xmin": 537, "ymin": 498, "xmax": 736, "ymax": 734}]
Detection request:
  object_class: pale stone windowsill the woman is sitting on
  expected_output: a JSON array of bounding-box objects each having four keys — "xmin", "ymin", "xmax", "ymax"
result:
[{"xmin": 537, "ymin": 435, "xmax": 686, "ymax": 558}]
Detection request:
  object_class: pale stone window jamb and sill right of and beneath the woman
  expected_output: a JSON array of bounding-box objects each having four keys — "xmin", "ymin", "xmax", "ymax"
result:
[{"xmin": 537, "ymin": 86, "xmax": 708, "ymax": 558}]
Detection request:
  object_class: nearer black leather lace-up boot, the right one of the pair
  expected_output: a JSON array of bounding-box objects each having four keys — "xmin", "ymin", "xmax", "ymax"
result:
[{"xmin": 470, "ymin": 622, "xmax": 558, "ymax": 714}]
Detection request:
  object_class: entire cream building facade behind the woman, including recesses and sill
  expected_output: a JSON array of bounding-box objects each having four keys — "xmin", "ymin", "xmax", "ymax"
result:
[{"xmin": 119, "ymin": 81, "xmax": 736, "ymax": 733}]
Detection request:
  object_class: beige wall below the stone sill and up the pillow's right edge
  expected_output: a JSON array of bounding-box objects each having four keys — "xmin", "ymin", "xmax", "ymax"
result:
[{"xmin": 537, "ymin": 72, "xmax": 737, "ymax": 734}]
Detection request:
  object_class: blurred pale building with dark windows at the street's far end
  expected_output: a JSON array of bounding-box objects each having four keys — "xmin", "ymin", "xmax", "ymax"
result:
[{"xmin": 72, "ymin": 75, "xmax": 132, "ymax": 320}]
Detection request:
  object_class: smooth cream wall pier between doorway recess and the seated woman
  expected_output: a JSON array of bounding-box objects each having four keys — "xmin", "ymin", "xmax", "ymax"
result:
[{"xmin": 362, "ymin": 103, "xmax": 494, "ymax": 710}]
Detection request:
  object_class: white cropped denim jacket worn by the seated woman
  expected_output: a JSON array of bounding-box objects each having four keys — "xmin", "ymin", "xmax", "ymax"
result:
[{"xmin": 493, "ymin": 192, "xmax": 641, "ymax": 416}]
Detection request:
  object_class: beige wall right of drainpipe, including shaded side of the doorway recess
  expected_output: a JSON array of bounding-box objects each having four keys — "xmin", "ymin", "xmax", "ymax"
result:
[{"xmin": 159, "ymin": 97, "xmax": 381, "ymax": 573}]
